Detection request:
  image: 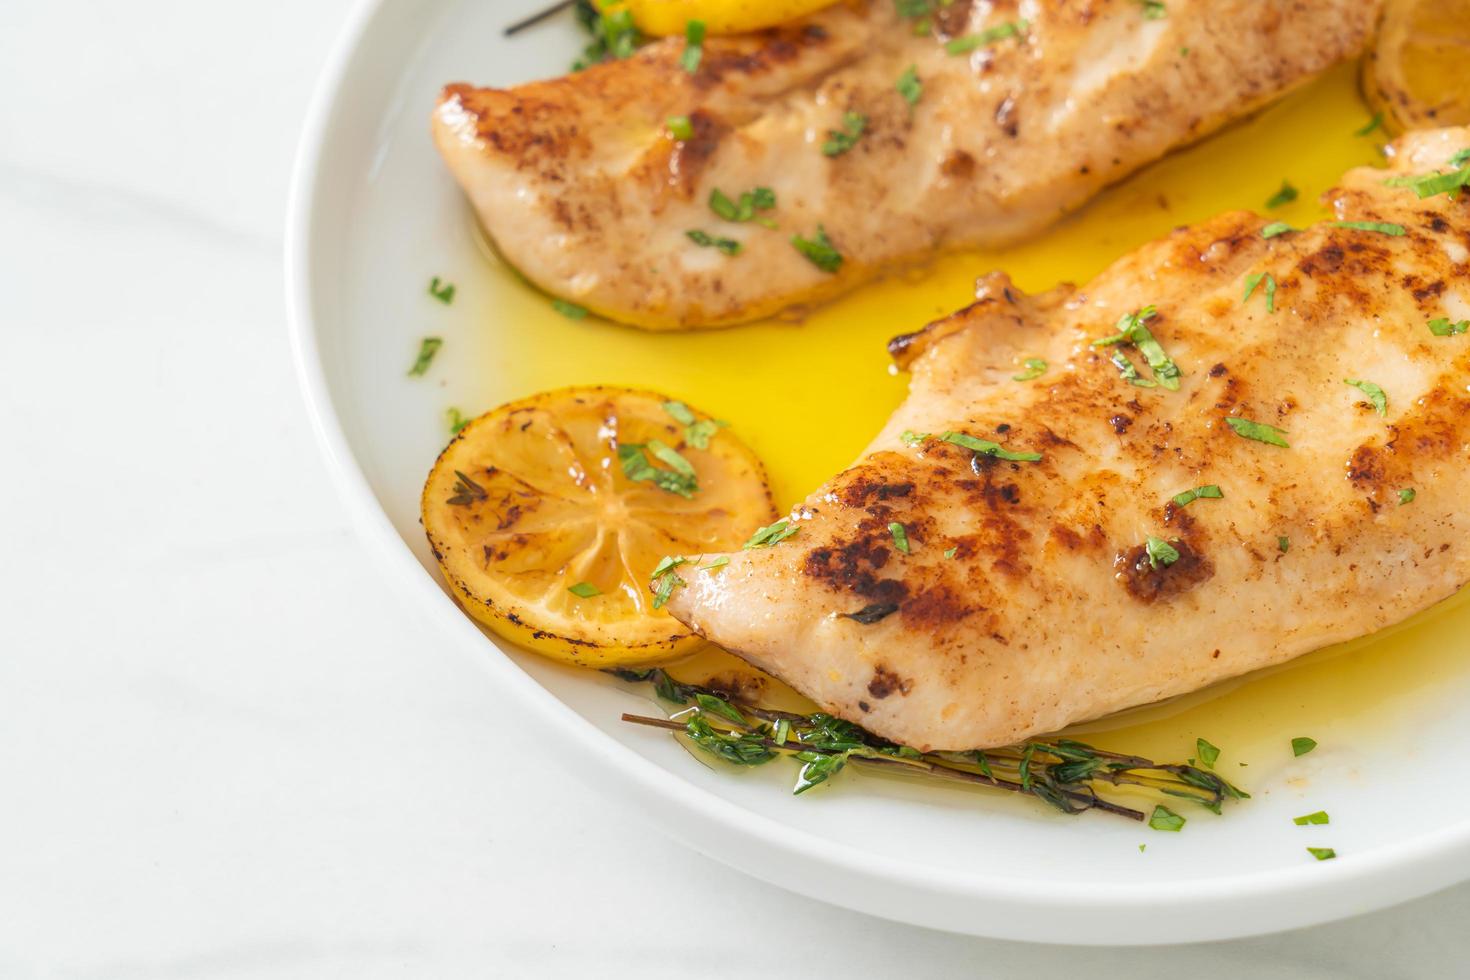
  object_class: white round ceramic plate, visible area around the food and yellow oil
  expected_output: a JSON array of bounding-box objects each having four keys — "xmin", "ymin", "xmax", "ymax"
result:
[{"xmin": 288, "ymin": 0, "xmax": 1470, "ymax": 943}]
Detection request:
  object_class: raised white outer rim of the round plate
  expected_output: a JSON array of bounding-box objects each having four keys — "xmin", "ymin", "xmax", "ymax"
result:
[{"xmin": 284, "ymin": 0, "xmax": 1470, "ymax": 946}]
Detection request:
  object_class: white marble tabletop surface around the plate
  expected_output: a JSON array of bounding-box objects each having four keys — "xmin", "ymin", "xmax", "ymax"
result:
[{"xmin": 0, "ymin": 0, "xmax": 1470, "ymax": 980}]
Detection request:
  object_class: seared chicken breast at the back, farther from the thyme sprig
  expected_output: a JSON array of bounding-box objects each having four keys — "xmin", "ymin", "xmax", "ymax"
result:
[{"xmin": 432, "ymin": 0, "xmax": 1379, "ymax": 329}]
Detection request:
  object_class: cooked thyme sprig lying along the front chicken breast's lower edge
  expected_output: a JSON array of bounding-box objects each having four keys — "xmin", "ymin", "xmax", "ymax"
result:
[{"xmin": 610, "ymin": 669, "xmax": 1250, "ymax": 823}]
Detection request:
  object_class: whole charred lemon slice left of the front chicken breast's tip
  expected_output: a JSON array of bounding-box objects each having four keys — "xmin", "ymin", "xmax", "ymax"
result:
[{"xmin": 422, "ymin": 388, "xmax": 775, "ymax": 667}]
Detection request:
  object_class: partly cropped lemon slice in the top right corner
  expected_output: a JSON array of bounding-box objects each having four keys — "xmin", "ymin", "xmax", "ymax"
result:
[{"xmin": 1363, "ymin": 0, "xmax": 1470, "ymax": 132}]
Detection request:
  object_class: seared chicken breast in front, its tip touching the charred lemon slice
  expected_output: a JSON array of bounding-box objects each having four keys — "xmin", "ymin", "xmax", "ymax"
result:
[{"xmin": 669, "ymin": 129, "xmax": 1470, "ymax": 749}]
